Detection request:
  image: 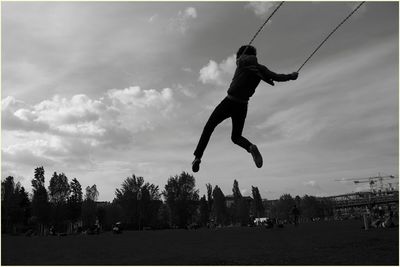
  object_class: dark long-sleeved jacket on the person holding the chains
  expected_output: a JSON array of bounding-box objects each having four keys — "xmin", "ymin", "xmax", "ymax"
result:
[{"xmin": 228, "ymin": 55, "xmax": 294, "ymax": 101}]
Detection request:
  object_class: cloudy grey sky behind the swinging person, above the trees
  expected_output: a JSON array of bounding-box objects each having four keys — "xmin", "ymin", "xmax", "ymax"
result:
[{"xmin": 1, "ymin": 2, "xmax": 399, "ymax": 201}]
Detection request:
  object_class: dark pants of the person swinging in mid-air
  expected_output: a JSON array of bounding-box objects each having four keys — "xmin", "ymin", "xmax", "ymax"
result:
[{"xmin": 194, "ymin": 98, "xmax": 252, "ymax": 159}]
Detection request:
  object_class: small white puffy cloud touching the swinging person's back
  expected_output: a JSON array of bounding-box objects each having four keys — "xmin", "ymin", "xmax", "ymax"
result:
[{"xmin": 199, "ymin": 55, "xmax": 236, "ymax": 85}]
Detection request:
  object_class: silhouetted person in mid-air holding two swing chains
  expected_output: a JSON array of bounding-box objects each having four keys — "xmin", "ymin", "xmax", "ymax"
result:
[{"xmin": 192, "ymin": 45, "xmax": 298, "ymax": 172}]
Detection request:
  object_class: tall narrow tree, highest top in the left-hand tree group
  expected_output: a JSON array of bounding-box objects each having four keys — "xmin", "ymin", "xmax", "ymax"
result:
[{"xmin": 32, "ymin": 166, "xmax": 50, "ymax": 234}]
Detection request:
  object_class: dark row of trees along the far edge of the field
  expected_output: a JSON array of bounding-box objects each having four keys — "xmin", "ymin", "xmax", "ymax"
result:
[{"xmin": 1, "ymin": 167, "xmax": 332, "ymax": 234}]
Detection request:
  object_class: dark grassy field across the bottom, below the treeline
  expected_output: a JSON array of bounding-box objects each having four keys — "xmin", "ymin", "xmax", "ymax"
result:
[{"xmin": 1, "ymin": 221, "xmax": 399, "ymax": 265}]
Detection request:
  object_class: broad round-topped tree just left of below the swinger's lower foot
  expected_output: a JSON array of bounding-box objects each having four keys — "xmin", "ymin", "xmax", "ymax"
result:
[{"xmin": 163, "ymin": 172, "xmax": 199, "ymax": 228}]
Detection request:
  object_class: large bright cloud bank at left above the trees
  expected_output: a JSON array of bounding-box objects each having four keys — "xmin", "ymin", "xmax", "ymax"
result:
[{"xmin": 2, "ymin": 86, "xmax": 178, "ymax": 170}]
